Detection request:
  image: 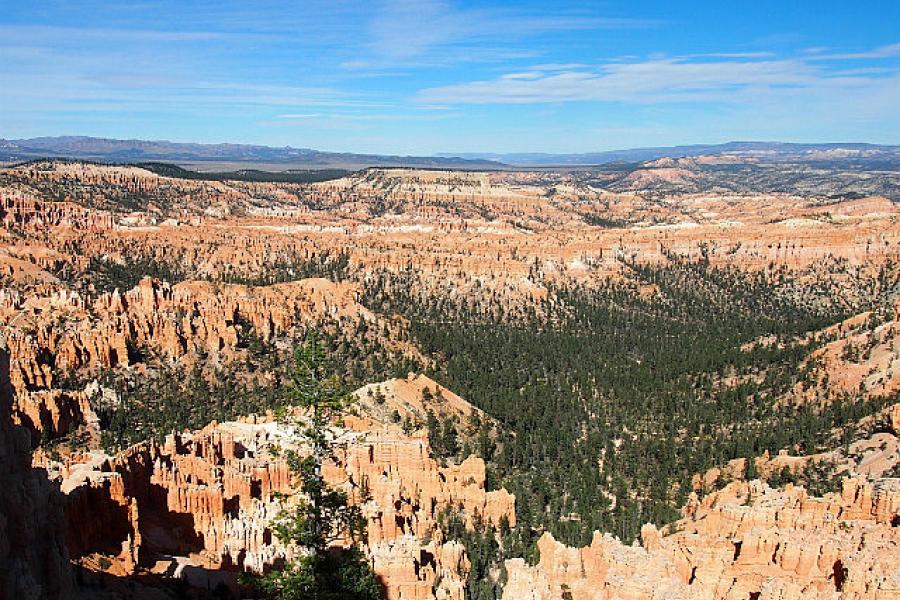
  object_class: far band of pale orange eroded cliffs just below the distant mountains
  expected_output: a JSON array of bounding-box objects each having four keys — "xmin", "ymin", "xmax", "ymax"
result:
[{"xmin": 8, "ymin": 161, "xmax": 900, "ymax": 293}]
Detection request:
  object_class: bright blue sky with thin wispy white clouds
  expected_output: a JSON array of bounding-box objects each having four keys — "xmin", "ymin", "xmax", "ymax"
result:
[{"xmin": 0, "ymin": 0, "xmax": 900, "ymax": 154}]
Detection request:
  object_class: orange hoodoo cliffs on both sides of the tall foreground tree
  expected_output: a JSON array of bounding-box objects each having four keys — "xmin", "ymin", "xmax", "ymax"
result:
[{"xmin": 52, "ymin": 408, "xmax": 515, "ymax": 600}]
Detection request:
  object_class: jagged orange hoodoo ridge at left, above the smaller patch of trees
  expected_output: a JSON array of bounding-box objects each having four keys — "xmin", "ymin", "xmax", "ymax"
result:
[{"xmin": 0, "ymin": 279, "xmax": 386, "ymax": 444}]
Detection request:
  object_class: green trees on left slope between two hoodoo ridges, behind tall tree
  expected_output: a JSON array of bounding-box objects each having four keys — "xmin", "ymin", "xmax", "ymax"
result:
[{"xmin": 82, "ymin": 317, "xmax": 419, "ymax": 452}]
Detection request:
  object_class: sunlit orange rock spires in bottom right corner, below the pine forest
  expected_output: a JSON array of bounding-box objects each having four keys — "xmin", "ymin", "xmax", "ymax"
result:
[{"xmin": 503, "ymin": 479, "xmax": 900, "ymax": 600}]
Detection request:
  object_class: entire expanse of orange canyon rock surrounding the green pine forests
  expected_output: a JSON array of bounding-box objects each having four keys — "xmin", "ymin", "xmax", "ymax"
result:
[{"xmin": 0, "ymin": 161, "xmax": 900, "ymax": 600}]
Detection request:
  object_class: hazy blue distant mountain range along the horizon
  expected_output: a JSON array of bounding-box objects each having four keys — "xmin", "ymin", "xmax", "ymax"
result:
[{"xmin": 0, "ymin": 136, "xmax": 900, "ymax": 170}]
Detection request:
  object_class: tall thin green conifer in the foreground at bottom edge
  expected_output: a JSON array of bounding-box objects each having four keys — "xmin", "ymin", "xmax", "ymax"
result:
[{"xmin": 250, "ymin": 339, "xmax": 384, "ymax": 600}]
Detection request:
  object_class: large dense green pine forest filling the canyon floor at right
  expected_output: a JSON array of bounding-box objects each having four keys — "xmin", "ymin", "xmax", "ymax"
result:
[{"xmin": 365, "ymin": 256, "xmax": 888, "ymax": 556}]
